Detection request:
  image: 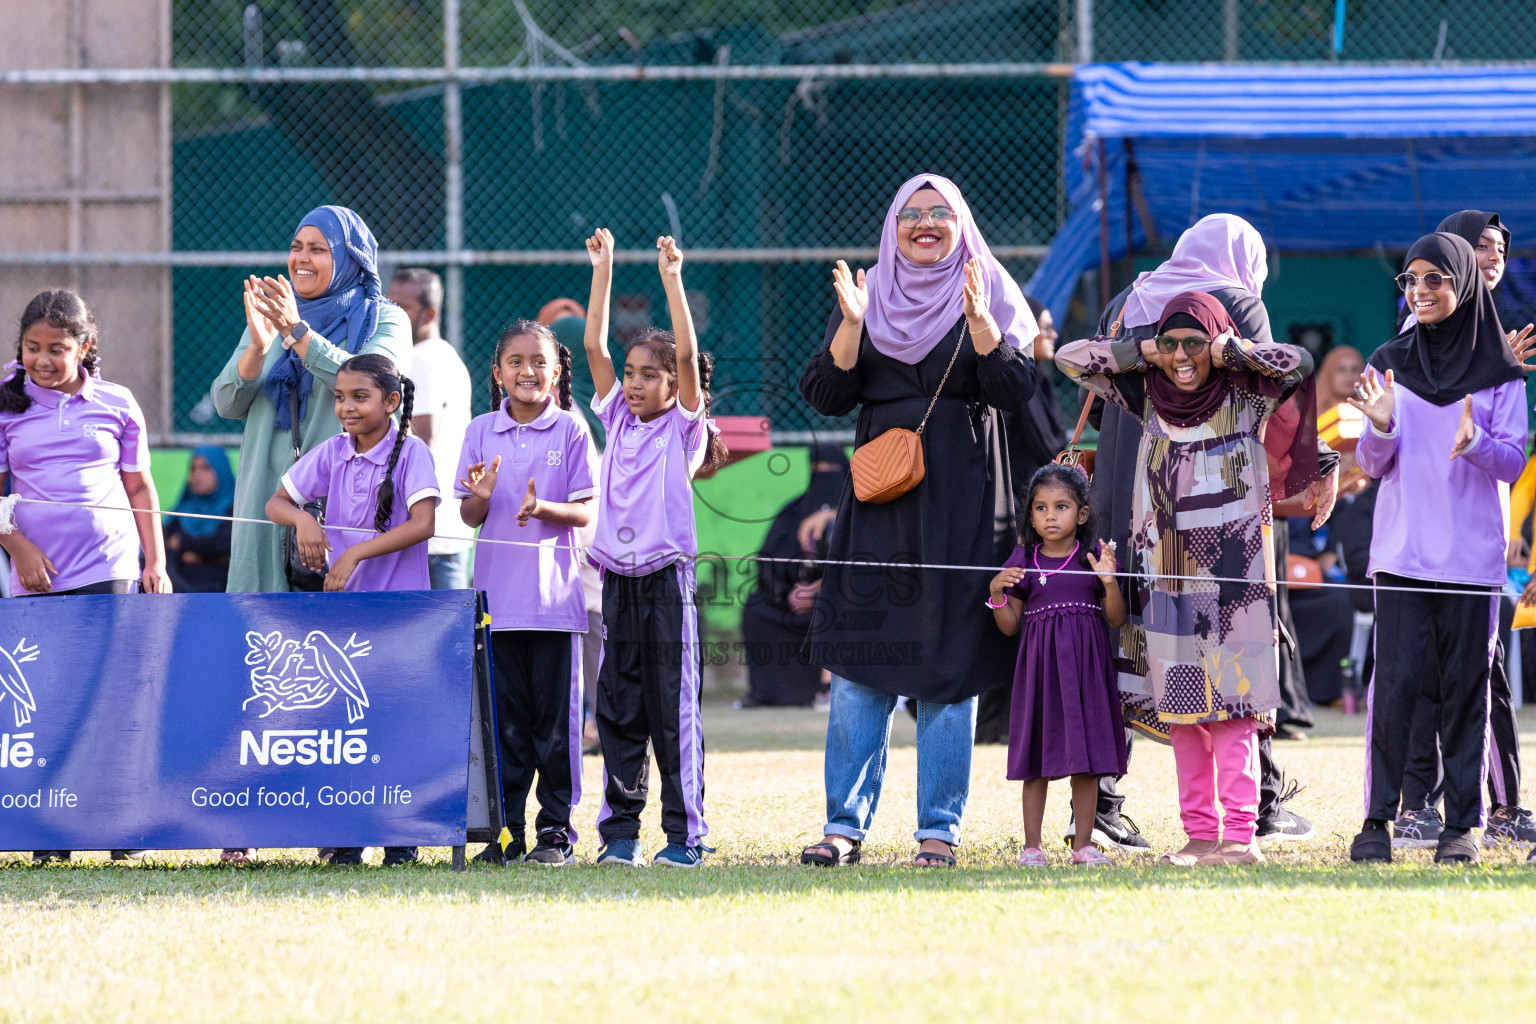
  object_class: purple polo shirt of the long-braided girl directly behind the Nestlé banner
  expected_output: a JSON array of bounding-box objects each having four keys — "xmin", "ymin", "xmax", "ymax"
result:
[{"xmin": 283, "ymin": 425, "xmax": 442, "ymax": 593}]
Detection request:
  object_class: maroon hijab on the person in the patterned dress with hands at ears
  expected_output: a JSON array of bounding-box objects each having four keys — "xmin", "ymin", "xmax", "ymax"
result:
[{"xmin": 1146, "ymin": 292, "xmax": 1322, "ymax": 500}]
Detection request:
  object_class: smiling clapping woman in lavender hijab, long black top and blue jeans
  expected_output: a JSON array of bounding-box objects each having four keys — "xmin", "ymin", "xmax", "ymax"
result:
[{"xmin": 800, "ymin": 175, "xmax": 1038, "ymax": 867}]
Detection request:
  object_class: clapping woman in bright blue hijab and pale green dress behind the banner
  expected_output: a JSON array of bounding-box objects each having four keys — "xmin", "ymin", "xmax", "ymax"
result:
[{"xmin": 212, "ymin": 206, "xmax": 412, "ymax": 593}]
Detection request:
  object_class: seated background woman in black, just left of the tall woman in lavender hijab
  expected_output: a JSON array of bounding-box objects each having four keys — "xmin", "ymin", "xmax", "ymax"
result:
[{"xmin": 742, "ymin": 444, "xmax": 848, "ymax": 708}]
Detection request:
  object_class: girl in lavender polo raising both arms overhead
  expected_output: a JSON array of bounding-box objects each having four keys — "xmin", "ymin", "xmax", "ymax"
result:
[{"xmin": 584, "ymin": 230, "xmax": 725, "ymax": 867}]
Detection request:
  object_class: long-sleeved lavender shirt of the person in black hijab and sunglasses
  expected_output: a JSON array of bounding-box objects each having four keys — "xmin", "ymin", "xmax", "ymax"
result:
[{"xmin": 1355, "ymin": 374, "xmax": 1525, "ymax": 586}]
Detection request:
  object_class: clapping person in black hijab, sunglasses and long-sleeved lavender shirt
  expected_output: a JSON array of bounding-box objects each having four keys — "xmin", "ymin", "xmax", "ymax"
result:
[{"xmin": 1347, "ymin": 232, "xmax": 1527, "ymax": 863}]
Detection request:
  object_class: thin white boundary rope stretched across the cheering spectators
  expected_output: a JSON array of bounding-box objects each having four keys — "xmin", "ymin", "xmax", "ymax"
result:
[{"xmin": 11, "ymin": 494, "xmax": 1523, "ymax": 597}]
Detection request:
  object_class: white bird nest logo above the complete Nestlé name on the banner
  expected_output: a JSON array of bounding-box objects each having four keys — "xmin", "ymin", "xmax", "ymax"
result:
[{"xmin": 241, "ymin": 629, "xmax": 373, "ymax": 723}]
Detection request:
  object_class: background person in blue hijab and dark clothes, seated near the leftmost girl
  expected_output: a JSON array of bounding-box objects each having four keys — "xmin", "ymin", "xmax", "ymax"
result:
[{"xmin": 160, "ymin": 445, "xmax": 235, "ymax": 594}]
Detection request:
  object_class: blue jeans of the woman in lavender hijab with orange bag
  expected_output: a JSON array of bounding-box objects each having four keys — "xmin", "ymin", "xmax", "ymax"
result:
[{"xmin": 822, "ymin": 674, "xmax": 975, "ymax": 846}]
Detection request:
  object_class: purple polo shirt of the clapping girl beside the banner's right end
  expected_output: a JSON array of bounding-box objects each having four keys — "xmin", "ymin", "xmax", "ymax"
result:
[{"xmin": 453, "ymin": 399, "xmax": 598, "ymax": 633}]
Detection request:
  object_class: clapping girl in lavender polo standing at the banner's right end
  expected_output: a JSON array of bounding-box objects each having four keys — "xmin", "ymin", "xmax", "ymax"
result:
[{"xmin": 458, "ymin": 319, "xmax": 598, "ymax": 866}]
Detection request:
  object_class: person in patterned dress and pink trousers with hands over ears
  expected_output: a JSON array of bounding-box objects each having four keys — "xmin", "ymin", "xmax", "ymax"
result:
[{"xmin": 1055, "ymin": 292, "xmax": 1318, "ymax": 866}]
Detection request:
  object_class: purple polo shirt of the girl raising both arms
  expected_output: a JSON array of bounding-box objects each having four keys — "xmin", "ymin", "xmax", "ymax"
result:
[{"xmin": 591, "ymin": 382, "xmax": 710, "ymax": 576}]
